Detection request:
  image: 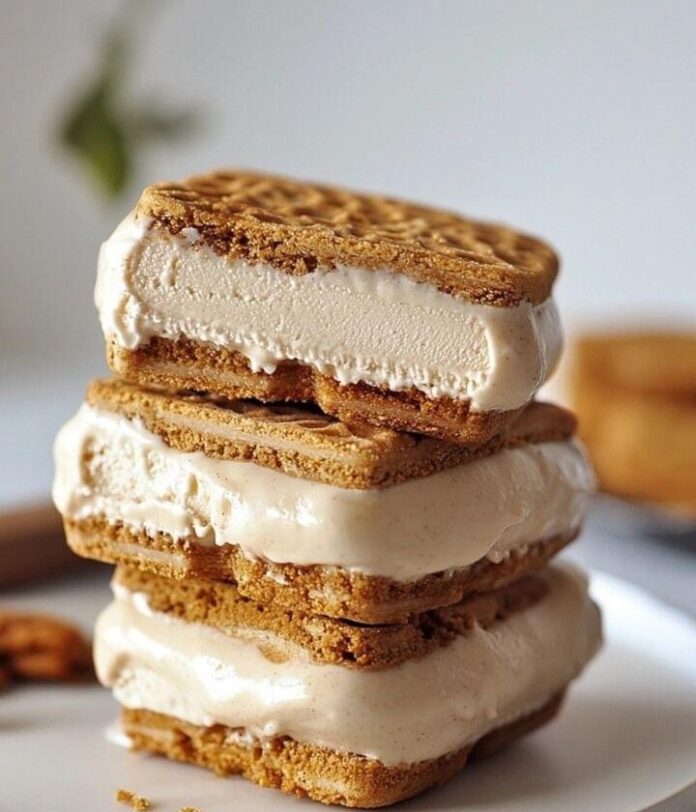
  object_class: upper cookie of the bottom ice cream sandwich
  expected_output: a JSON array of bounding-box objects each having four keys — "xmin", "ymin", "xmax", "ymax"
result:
[{"xmin": 115, "ymin": 567, "xmax": 548, "ymax": 670}]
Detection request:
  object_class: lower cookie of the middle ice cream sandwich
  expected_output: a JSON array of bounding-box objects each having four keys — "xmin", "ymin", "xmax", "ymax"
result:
[{"xmin": 65, "ymin": 517, "xmax": 577, "ymax": 623}]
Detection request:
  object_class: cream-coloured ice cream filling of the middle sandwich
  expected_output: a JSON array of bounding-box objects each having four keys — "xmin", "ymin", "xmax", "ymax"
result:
[{"xmin": 53, "ymin": 405, "xmax": 594, "ymax": 581}]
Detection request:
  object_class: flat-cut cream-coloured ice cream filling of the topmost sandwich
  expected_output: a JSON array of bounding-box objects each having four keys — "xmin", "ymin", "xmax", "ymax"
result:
[{"xmin": 95, "ymin": 215, "xmax": 561, "ymax": 411}]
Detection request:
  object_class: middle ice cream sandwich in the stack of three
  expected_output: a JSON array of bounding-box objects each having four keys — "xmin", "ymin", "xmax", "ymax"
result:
[{"xmin": 54, "ymin": 380, "xmax": 593, "ymax": 623}]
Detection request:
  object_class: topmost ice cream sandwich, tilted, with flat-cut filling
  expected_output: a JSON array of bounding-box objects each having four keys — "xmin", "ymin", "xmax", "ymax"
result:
[{"xmin": 96, "ymin": 172, "xmax": 561, "ymax": 444}]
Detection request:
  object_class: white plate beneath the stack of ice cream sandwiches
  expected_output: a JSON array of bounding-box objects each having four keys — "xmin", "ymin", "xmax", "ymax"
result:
[{"xmin": 0, "ymin": 575, "xmax": 696, "ymax": 812}]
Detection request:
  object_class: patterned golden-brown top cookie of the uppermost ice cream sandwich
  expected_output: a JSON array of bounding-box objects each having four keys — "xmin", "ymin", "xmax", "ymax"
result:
[{"xmin": 136, "ymin": 170, "xmax": 558, "ymax": 307}]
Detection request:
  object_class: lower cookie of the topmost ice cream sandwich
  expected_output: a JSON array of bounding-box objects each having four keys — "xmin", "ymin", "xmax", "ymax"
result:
[{"xmin": 106, "ymin": 338, "xmax": 520, "ymax": 445}]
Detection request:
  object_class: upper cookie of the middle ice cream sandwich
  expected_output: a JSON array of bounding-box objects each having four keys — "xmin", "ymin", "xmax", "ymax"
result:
[{"xmin": 87, "ymin": 380, "xmax": 575, "ymax": 489}]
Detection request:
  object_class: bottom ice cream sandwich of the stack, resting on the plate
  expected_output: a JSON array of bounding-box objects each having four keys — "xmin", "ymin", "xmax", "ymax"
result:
[{"xmin": 95, "ymin": 567, "xmax": 601, "ymax": 808}]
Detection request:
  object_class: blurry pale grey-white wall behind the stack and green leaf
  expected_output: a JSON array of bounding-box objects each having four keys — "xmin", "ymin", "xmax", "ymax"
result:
[{"xmin": 0, "ymin": 0, "xmax": 696, "ymax": 506}]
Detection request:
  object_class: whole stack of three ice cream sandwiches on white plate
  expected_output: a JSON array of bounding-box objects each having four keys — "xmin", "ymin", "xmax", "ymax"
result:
[{"xmin": 54, "ymin": 172, "xmax": 601, "ymax": 807}]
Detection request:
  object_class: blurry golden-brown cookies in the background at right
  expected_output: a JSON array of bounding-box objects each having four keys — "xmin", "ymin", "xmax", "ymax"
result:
[{"xmin": 570, "ymin": 332, "xmax": 696, "ymax": 522}]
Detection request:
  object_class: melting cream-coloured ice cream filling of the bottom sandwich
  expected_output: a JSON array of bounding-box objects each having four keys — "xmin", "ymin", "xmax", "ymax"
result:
[{"xmin": 95, "ymin": 567, "xmax": 601, "ymax": 764}]
